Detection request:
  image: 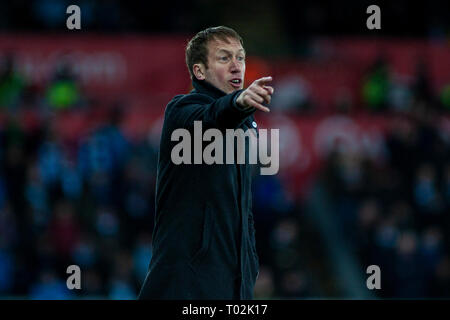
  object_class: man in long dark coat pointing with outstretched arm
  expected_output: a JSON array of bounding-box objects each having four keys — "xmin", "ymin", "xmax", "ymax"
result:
[{"xmin": 139, "ymin": 27, "xmax": 273, "ymax": 300}]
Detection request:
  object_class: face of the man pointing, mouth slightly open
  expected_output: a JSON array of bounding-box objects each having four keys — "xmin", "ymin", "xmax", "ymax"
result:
[{"xmin": 200, "ymin": 38, "xmax": 245, "ymax": 94}]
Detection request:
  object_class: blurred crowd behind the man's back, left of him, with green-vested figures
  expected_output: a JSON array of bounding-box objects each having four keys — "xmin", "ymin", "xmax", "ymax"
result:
[{"xmin": 0, "ymin": 52, "xmax": 157, "ymax": 299}]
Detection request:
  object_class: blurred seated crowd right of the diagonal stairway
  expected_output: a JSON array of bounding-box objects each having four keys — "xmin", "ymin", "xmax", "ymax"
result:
[{"xmin": 322, "ymin": 109, "xmax": 450, "ymax": 298}]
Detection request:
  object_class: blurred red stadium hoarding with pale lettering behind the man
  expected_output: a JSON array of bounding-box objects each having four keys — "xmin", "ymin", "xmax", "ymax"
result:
[{"xmin": 0, "ymin": 35, "xmax": 450, "ymax": 198}]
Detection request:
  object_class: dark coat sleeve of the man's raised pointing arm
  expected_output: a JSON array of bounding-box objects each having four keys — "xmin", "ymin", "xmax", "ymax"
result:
[{"xmin": 171, "ymin": 90, "xmax": 255, "ymax": 129}]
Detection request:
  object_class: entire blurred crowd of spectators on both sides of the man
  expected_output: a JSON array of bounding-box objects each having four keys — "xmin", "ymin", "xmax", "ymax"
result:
[{"xmin": 0, "ymin": 38, "xmax": 450, "ymax": 299}]
